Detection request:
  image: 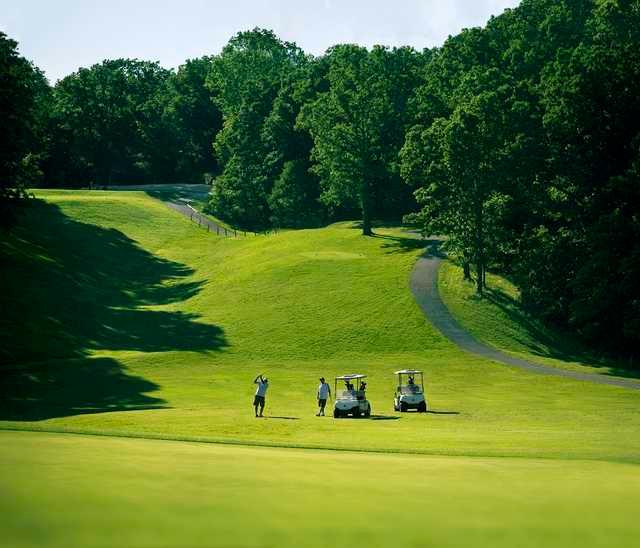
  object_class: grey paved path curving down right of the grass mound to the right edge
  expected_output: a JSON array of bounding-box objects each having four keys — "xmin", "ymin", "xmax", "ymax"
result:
[{"xmin": 410, "ymin": 251, "xmax": 640, "ymax": 390}]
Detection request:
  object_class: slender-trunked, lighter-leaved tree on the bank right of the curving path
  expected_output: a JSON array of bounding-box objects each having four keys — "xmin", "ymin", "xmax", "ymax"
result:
[{"xmin": 401, "ymin": 73, "xmax": 510, "ymax": 294}]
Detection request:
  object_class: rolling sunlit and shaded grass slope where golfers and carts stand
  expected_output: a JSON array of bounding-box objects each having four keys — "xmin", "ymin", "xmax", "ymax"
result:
[{"xmin": 0, "ymin": 191, "xmax": 640, "ymax": 462}]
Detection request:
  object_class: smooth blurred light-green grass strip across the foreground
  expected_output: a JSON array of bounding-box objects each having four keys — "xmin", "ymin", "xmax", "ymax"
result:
[{"xmin": 0, "ymin": 432, "xmax": 640, "ymax": 548}]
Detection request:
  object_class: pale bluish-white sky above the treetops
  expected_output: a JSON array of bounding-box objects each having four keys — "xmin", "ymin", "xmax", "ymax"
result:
[{"xmin": 0, "ymin": 0, "xmax": 519, "ymax": 83}]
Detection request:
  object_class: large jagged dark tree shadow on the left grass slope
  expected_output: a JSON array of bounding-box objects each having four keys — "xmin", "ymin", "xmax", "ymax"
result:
[{"xmin": 0, "ymin": 201, "xmax": 227, "ymax": 420}]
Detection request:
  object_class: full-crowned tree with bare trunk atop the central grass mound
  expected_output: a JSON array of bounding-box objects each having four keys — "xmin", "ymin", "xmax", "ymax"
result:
[{"xmin": 299, "ymin": 45, "xmax": 417, "ymax": 235}]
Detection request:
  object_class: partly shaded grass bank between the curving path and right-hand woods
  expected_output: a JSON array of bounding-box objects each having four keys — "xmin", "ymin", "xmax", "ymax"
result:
[{"xmin": 438, "ymin": 261, "xmax": 640, "ymax": 377}]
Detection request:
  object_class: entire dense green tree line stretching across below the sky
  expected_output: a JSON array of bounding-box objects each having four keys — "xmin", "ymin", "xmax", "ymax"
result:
[{"xmin": 0, "ymin": 0, "xmax": 640, "ymax": 352}]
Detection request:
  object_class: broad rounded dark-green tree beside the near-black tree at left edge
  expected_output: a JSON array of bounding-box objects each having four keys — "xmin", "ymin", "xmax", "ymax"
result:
[{"xmin": 54, "ymin": 59, "xmax": 175, "ymax": 184}]
